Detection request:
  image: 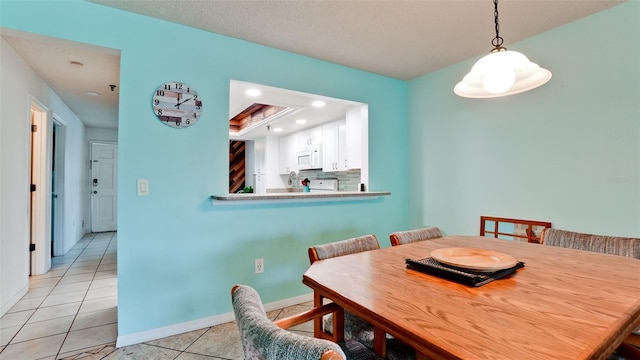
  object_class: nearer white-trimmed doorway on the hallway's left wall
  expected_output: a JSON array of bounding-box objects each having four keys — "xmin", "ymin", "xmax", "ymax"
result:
[{"xmin": 26, "ymin": 95, "xmax": 53, "ymax": 275}]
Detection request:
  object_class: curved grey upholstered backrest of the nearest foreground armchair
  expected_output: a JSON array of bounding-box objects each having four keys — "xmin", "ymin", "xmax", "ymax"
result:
[{"xmin": 231, "ymin": 285, "xmax": 346, "ymax": 360}]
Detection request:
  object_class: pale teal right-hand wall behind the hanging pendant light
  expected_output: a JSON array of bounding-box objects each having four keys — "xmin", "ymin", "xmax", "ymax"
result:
[{"xmin": 409, "ymin": 2, "xmax": 640, "ymax": 237}]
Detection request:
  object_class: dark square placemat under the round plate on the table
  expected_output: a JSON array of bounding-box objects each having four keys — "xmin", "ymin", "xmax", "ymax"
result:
[{"xmin": 405, "ymin": 257, "xmax": 524, "ymax": 287}]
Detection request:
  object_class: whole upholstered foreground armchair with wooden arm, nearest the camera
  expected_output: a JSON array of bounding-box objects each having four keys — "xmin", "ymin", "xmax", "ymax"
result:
[{"xmin": 231, "ymin": 285, "xmax": 382, "ymax": 360}]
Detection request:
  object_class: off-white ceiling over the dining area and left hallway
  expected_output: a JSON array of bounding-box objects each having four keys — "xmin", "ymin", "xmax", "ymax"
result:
[{"xmin": 0, "ymin": 0, "xmax": 624, "ymax": 128}]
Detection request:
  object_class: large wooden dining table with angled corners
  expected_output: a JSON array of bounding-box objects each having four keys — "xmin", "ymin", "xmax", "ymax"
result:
[{"xmin": 302, "ymin": 236, "xmax": 640, "ymax": 360}]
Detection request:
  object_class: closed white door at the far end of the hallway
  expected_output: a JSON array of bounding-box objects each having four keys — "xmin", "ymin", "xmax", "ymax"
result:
[{"xmin": 90, "ymin": 143, "xmax": 118, "ymax": 232}]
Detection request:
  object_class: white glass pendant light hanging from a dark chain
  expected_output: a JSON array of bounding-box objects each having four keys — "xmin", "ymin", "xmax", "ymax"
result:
[{"xmin": 453, "ymin": 0, "xmax": 551, "ymax": 98}]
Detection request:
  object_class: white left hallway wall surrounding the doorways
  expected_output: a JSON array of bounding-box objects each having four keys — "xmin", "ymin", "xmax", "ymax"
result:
[{"xmin": 0, "ymin": 39, "xmax": 88, "ymax": 316}]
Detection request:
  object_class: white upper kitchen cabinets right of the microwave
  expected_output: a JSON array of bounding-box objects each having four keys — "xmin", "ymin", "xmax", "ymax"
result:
[{"xmin": 322, "ymin": 106, "xmax": 366, "ymax": 172}]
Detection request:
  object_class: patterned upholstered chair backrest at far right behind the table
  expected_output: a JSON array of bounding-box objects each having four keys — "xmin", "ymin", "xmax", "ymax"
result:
[{"xmin": 541, "ymin": 229, "xmax": 640, "ymax": 259}]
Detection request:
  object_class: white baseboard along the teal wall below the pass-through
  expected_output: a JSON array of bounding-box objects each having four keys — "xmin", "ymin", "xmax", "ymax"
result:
[{"xmin": 116, "ymin": 293, "xmax": 313, "ymax": 348}]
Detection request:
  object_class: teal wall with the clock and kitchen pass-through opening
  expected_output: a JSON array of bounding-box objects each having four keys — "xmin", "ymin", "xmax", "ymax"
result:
[{"xmin": 0, "ymin": 1, "xmax": 409, "ymax": 337}]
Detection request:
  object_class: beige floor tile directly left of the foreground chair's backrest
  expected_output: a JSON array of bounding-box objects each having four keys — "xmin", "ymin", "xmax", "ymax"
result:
[{"xmin": 185, "ymin": 322, "xmax": 244, "ymax": 359}]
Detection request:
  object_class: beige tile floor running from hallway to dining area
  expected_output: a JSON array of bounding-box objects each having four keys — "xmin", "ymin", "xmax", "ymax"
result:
[{"xmin": 0, "ymin": 232, "xmax": 313, "ymax": 360}]
